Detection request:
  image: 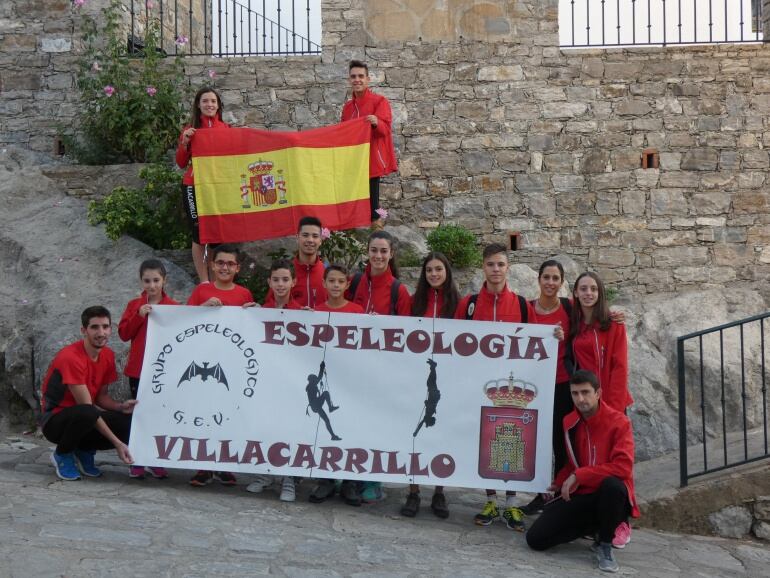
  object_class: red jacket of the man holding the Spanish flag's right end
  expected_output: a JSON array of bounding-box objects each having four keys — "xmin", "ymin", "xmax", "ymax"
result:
[{"xmin": 342, "ymin": 89, "xmax": 398, "ymax": 179}]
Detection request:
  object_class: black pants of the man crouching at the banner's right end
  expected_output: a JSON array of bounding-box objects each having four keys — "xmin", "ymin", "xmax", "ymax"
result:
[{"xmin": 527, "ymin": 476, "xmax": 631, "ymax": 550}]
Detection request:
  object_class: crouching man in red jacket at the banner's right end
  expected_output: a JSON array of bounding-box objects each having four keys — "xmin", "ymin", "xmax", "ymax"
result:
[{"xmin": 527, "ymin": 370, "xmax": 639, "ymax": 572}]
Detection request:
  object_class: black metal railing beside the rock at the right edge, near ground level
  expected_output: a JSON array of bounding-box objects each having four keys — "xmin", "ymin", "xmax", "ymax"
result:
[{"xmin": 676, "ymin": 312, "xmax": 770, "ymax": 486}]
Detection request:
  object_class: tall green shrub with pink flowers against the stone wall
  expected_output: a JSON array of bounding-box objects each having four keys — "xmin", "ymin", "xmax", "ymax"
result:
[{"xmin": 60, "ymin": 0, "xmax": 188, "ymax": 164}]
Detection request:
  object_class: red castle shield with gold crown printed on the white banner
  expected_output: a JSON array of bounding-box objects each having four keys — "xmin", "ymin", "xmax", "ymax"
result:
[{"xmin": 479, "ymin": 372, "xmax": 537, "ymax": 482}]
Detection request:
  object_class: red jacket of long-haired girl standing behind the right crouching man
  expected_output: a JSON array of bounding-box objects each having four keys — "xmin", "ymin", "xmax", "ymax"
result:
[{"xmin": 572, "ymin": 321, "xmax": 634, "ymax": 412}]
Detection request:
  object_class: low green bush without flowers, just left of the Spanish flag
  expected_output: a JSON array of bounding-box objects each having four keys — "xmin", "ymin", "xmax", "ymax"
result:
[{"xmin": 88, "ymin": 164, "xmax": 192, "ymax": 249}]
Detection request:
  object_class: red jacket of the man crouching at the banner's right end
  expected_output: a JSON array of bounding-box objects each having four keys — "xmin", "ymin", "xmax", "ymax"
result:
[{"xmin": 553, "ymin": 400, "xmax": 639, "ymax": 518}]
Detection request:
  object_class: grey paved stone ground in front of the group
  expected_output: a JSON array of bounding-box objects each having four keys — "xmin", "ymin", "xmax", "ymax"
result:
[{"xmin": 0, "ymin": 436, "xmax": 770, "ymax": 578}]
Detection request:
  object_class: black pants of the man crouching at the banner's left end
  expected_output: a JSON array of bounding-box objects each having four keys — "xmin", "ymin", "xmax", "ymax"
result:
[{"xmin": 43, "ymin": 404, "xmax": 131, "ymax": 454}]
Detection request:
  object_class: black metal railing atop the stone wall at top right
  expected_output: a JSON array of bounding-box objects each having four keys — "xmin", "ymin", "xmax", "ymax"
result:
[{"xmin": 559, "ymin": 0, "xmax": 763, "ymax": 48}]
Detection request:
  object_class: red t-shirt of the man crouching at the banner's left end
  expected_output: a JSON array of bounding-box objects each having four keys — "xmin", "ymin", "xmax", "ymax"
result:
[{"xmin": 40, "ymin": 339, "xmax": 118, "ymax": 424}]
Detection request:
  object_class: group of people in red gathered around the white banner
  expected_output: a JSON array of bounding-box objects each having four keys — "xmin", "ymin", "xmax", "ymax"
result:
[{"xmin": 42, "ymin": 216, "xmax": 638, "ymax": 571}]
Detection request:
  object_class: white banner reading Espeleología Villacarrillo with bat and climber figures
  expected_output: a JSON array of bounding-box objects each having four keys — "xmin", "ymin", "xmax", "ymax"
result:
[{"xmin": 129, "ymin": 306, "xmax": 557, "ymax": 491}]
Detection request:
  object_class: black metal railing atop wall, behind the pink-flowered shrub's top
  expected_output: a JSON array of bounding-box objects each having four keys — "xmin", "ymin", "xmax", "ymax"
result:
[{"xmin": 127, "ymin": 0, "xmax": 321, "ymax": 56}]
